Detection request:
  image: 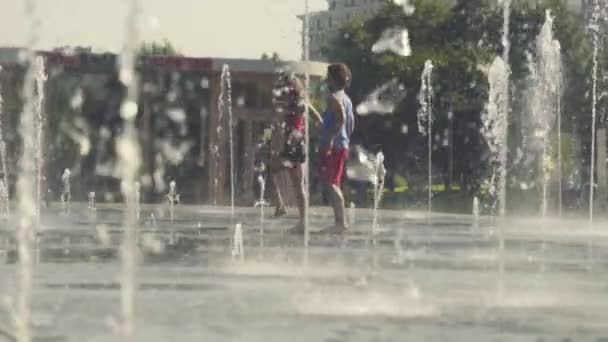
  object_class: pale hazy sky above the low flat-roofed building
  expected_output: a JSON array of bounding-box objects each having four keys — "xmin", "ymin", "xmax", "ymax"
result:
[{"xmin": 0, "ymin": 0, "xmax": 327, "ymax": 59}]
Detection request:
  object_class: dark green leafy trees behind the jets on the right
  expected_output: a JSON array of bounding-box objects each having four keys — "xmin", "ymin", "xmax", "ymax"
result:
[{"xmin": 322, "ymin": 0, "xmax": 591, "ymax": 198}]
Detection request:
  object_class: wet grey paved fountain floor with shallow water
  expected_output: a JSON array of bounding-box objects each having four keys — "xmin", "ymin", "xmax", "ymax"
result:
[{"xmin": 0, "ymin": 204, "xmax": 608, "ymax": 342}]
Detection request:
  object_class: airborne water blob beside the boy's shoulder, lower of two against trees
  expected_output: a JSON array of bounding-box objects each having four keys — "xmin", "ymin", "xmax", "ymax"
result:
[{"xmin": 357, "ymin": 79, "xmax": 405, "ymax": 115}]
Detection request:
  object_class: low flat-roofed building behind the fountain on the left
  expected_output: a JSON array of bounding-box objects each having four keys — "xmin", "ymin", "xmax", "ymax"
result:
[{"xmin": 0, "ymin": 48, "xmax": 326, "ymax": 205}]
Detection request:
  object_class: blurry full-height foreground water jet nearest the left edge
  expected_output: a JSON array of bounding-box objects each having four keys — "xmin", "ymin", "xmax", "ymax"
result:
[{"xmin": 14, "ymin": 0, "xmax": 41, "ymax": 342}]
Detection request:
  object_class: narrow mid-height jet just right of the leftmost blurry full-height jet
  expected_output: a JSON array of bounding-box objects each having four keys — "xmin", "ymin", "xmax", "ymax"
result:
[{"xmin": 34, "ymin": 57, "xmax": 48, "ymax": 224}]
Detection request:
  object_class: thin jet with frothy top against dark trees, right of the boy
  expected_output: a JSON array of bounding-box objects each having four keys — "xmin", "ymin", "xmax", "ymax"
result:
[{"xmin": 418, "ymin": 60, "xmax": 433, "ymax": 219}]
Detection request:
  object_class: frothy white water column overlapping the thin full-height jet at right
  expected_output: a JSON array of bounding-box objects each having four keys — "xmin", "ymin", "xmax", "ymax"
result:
[{"xmin": 481, "ymin": 57, "xmax": 508, "ymax": 215}]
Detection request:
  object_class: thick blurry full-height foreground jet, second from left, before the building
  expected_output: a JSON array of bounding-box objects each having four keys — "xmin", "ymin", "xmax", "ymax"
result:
[{"xmin": 116, "ymin": 0, "xmax": 141, "ymax": 341}]
